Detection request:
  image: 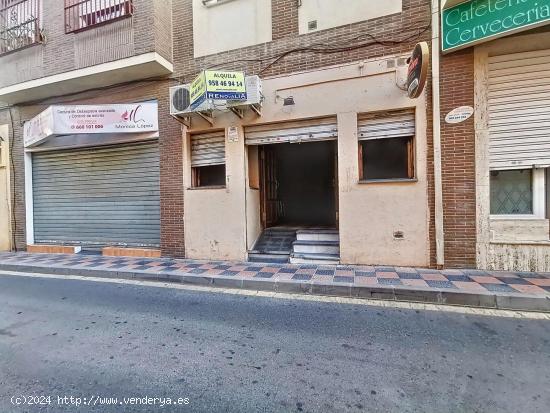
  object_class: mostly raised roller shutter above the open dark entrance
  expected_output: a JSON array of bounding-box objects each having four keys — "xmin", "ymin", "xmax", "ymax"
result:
[{"xmin": 245, "ymin": 118, "xmax": 338, "ymax": 145}]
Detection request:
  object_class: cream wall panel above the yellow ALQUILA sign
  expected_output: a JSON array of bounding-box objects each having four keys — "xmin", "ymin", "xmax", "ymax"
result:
[{"xmin": 193, "ymin": 0, "xmax": 271, "ymax": 57}]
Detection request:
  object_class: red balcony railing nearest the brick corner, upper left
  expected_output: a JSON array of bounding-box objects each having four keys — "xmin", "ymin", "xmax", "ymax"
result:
[{"xmin": 65, "ymin": 0, "xmax": 134, "ymax": 33}]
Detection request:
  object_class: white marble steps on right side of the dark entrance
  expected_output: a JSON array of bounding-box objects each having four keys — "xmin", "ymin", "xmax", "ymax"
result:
[{"xmin": 290, "ymin": 229, "xmax": 340, "ymax": 265}]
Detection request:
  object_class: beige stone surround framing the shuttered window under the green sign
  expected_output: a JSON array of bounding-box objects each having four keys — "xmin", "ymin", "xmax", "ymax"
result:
[{"xmin": 474, "ymin": 33, "xmax": 550, "ymax": 271}]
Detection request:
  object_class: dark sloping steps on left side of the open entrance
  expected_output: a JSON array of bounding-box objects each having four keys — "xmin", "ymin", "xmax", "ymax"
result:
[{"xmin": 248, "ymin": 227, "xmax": 296, "ymax": 264}]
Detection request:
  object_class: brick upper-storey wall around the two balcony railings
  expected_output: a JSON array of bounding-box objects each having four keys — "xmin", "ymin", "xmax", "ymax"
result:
[{"xmin": 0, "ymin": 0, "xmax": 172, "ymax": 87}]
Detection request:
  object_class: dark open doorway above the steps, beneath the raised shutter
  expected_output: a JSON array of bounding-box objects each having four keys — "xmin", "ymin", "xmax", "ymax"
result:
[{"xmin": 260, "ymin": 141, "xmax": 337, "ymax": 227}]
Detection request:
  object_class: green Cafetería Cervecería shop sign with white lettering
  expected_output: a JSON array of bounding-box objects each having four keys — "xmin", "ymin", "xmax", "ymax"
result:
[{"xmin": 441, "ymin": 0, "xmax": 550, "ymax": 52}]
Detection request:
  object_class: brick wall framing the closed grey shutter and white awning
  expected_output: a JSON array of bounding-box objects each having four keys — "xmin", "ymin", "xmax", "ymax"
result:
[{"xmin": 0, "ymin": 81, "xmax": 184, "ymax": 257}]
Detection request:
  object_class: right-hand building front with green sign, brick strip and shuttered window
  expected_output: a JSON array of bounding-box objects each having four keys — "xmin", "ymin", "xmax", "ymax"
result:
[{"xmin": 441, "ymin": 1, "xmax": 550, "ymax": 271}]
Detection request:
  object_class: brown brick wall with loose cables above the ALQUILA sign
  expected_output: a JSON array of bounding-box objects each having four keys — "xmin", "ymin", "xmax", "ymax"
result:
[{"xmin": 173, "ymin": 0, "xmax": 431, "ymax": 83}]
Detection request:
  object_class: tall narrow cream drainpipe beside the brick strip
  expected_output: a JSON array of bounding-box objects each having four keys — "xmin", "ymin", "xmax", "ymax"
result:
[{"xmin": 432, "ymin": 0, "xmax": 445, "ymax": 268}]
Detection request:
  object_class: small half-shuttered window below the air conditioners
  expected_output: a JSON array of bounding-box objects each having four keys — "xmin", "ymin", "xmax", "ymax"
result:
[{"xmin": 191, "ymin": 130, "xmax": 225, "ymax": 188}]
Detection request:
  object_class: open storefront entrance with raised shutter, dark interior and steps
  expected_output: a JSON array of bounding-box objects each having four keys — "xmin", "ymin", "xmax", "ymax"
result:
[{"xmin": 246, "ymin": 118, "xmax": 340, "ymax": 264}]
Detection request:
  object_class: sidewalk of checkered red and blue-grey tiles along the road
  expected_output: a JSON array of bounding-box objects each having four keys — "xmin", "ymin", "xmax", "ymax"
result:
[{"xmin": 0, "ymin": 249, "xmax": 550, "ymax": 311}]
